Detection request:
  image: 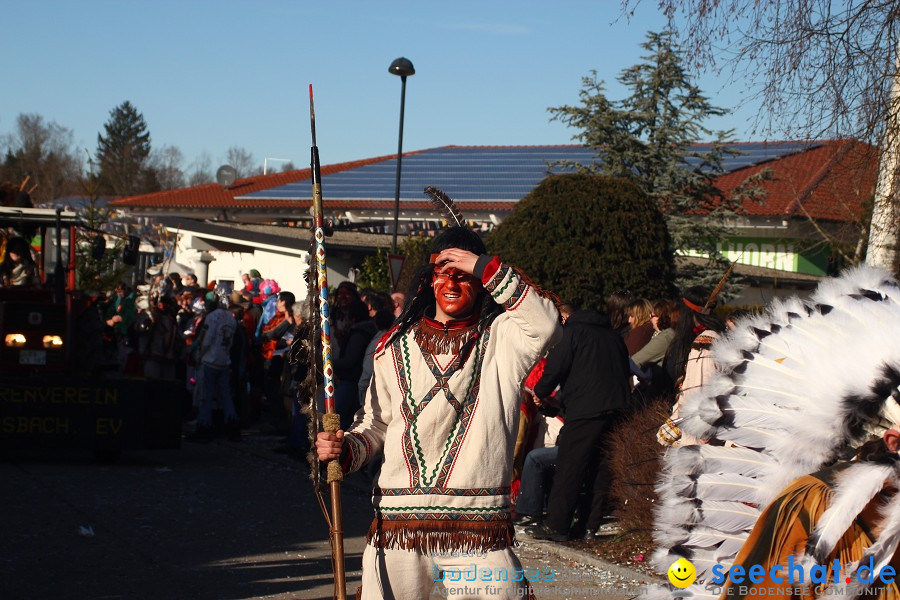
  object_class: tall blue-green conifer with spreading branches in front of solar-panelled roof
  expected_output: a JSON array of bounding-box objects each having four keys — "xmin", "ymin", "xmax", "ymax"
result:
[{"xmin": 549, "ymin": 32, "xmax": 766, "ymax": 287}]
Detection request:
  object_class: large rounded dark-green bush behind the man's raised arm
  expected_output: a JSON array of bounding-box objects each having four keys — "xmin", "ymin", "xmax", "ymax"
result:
[{"xmin": 487, "ymin": 173, "xmax": 674, "ymax": 309}]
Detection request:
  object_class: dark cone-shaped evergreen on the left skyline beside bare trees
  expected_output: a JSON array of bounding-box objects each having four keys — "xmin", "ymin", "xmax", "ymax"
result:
[{"xmin": 97, "ymin": 100, "xmax": 159, "ymax": 196}]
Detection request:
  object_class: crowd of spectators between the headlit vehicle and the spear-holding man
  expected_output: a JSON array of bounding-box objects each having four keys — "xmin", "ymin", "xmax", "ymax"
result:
[{"xmin": 75, "ymin": 269, "xmax": 403, "ymax": 457}]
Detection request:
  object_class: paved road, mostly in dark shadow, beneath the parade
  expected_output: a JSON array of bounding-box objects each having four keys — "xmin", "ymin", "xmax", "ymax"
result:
[{"xmin": 0, "ymin": 435, "xmax": 648, "ymax": 600}]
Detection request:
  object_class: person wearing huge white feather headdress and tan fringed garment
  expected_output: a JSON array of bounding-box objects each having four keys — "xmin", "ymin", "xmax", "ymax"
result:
[{"xmin": 651, "ymin": 267, "xmax": 900, "ymax": 599}]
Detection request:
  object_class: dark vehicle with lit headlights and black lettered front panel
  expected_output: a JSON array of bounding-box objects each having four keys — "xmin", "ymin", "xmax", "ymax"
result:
[{"xmin": 0, "ymin": 207, "xmax": 181, "ymax": 458}]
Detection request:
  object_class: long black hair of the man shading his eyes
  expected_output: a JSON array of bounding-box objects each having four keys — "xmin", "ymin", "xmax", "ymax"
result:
[{"xmin": 387, "ymin": 226, "xmax": 503, "ymax": 344}]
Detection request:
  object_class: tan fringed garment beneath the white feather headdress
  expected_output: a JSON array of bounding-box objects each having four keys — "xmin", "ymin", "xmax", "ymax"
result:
[{"xmin": 722, "ymin": 464, "xmax": 900, "ymax": 600}]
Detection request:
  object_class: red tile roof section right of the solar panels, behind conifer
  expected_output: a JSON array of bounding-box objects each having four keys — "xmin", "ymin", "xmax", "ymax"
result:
[{"xmin": 716, "ymin": 140, "xmax": 878, "ymax": 221}]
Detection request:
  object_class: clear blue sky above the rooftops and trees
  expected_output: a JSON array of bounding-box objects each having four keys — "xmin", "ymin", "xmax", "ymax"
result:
[{"xmin": 0, "ymin": 0, "xmax": 760, "ymax": 168}]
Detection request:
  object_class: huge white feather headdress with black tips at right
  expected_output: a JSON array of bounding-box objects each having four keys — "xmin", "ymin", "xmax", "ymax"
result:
[{"xmin": 653, "ymin": 267, "xmax": 900, "ymax": 598}]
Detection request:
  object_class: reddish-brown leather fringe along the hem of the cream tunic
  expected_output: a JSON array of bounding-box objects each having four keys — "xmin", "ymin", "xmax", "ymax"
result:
[{"xmin": 366, "ymin": 517, "xmax": 516, "ymax": 554}]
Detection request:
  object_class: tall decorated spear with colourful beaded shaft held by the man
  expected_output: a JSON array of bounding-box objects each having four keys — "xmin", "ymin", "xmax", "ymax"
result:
[{"xmin": 309, "ymin": 84, "xmax": 347, "ymax": 600}]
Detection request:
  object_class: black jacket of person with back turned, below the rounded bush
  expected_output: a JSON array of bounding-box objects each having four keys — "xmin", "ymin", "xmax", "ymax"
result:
[{"xmin": 534, "ymin": 310, "xmax": 631, "ymax": 423}]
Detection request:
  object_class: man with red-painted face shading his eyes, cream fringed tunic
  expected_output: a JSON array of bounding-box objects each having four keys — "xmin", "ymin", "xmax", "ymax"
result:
[{"xmin": 316, "ymin": 226, "xmax": 561, "ymax": 598}]
